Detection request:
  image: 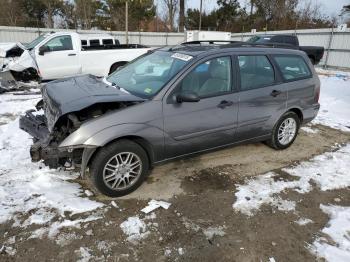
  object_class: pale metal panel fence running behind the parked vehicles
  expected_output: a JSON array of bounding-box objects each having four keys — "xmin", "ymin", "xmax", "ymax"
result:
[{"xmin": 0, "ymin": 26, "xmax": 350, "ymax": 69}]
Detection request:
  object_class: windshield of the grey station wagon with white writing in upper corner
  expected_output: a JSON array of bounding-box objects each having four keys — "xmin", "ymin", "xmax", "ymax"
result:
[{"xmin": 107, "ymin": 51, "xmax": 192, "ymax": 99}]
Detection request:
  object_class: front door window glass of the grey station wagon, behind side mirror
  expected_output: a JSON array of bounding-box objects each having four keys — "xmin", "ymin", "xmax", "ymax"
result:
[{"xmin": 178, "ymin": 56, "xmax": 232, "ymax": 98}]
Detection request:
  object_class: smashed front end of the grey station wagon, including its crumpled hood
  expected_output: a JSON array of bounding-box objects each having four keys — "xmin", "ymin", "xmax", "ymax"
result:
[{"xmin": 19, "ymin": 75, "xmax": 144, "ymax": 173}]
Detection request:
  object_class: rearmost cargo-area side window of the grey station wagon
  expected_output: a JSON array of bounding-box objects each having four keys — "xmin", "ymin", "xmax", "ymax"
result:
[{"xmin": 274, "ymin": 55, "xmax": 311, "ymax": 81}]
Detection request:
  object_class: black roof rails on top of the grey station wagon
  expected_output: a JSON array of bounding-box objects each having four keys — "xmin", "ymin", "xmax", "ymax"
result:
[{"xmin": 181, "ymin": 40, "xmax": 298, "ymax": 49}]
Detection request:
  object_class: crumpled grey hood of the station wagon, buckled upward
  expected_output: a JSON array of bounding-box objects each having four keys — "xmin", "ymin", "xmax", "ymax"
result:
[{"xmin": 42, "ymin": 75, "xmax": 145, "ymax": 132}]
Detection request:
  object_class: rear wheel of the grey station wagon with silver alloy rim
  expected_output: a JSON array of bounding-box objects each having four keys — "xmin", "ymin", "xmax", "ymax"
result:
[{"xmin": 267, "ymin": 112, "xmax": 300, "ymax": 149}]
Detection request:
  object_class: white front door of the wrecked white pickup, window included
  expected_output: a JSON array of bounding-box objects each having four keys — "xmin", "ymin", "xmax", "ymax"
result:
[{"xmin": 35, "ymin": 35, "xmax": 81, "ymax": 80}]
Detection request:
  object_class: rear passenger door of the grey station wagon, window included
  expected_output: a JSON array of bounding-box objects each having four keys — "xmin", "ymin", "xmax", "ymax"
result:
[{"xmin": 236, "ymin": 53, "xmax": 288, "ymax": 140}]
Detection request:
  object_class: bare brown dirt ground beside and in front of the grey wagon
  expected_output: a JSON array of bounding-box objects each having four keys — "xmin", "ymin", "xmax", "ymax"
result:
[{"xmin": 0, "ymin": 126, "xmax": 350, "ymax": 262}]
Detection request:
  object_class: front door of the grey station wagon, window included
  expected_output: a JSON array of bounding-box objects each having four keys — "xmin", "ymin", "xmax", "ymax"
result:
[{"xmin": 163, "ymin": 56, "xmax": 238, "ymax": 158}]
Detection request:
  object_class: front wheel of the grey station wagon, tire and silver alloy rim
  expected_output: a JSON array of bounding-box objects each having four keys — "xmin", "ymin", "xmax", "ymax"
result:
[{"xmin": 90, "ymin": 140, "xmax": 149, "ymax": 197}]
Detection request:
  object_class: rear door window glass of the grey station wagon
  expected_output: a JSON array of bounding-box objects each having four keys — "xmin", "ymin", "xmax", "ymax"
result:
[{"xmin": 238, "ymin": 55, "xmax": 275, "ymax": 91}]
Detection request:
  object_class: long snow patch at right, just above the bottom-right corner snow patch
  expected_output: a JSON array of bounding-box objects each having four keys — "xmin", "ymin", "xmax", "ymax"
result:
[{"xmin": 233, "ymin": 144, "xmax": 350, "ymax": 216}]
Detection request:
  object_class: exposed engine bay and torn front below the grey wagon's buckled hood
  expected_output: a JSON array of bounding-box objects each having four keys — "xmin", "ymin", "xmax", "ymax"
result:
[{"xmin": 20, "ymin": 100, "xmax": 138, "ymax": 168}]
